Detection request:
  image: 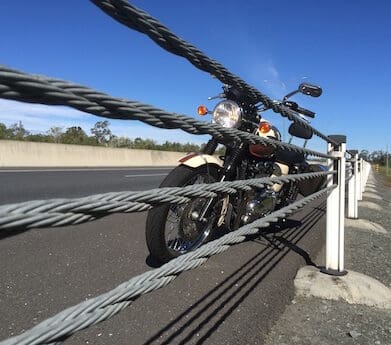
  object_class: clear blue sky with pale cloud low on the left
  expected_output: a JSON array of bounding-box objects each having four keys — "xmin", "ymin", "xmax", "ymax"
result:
[{"xmin": 0, "ymin": 0, "xmax": 391, "ymax": 150}]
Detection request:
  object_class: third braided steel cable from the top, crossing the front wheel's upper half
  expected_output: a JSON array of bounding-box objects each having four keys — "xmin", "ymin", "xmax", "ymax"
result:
[{"xmin": 0, "ymin": 171, "xmax": 335, "ymax": 230}]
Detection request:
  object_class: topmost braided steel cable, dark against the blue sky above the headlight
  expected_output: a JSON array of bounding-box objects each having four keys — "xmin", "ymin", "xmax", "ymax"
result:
[{"xmin": 90, "ymin": 0, "xmax": 337, "ymax": 145}]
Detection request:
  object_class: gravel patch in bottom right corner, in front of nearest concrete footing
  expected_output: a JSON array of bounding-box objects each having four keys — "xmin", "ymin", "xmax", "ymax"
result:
[{"xmin": 264, "ymin": 298, "xmax": 391, "ymax": 345}]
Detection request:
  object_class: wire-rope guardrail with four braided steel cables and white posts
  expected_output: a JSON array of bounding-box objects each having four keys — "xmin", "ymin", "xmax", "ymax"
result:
[{"xmin": 0, "ymin": 0, "xmax": 370, "ymax": 345}]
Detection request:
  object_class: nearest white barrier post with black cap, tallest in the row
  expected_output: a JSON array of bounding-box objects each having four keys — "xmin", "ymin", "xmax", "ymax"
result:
[{"xmin": 321, "ymin": 135, "xmax": 347, "ymax": 276}]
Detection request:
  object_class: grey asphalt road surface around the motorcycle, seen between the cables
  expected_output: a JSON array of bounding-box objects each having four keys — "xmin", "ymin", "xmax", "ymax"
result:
[{"xmin": 0, "ymin": 169, "xmax": 325, "ymax": 345}]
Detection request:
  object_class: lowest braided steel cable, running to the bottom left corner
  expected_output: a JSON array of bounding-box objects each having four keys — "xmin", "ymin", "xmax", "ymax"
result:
[{"xmin": 0, "ymin": 185, "xmax": 336, "ymax": 345}]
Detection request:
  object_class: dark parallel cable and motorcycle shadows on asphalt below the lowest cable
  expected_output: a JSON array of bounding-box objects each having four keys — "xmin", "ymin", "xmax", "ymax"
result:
[{"xmin": 144, "ymin": 202, "xmax": 325, "ymax": 345}]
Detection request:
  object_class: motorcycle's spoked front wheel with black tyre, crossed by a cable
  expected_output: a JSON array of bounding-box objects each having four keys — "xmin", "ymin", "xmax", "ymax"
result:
[{"xmin": 146, "ymin": 164, "xmax": 219, "ymax": 263}]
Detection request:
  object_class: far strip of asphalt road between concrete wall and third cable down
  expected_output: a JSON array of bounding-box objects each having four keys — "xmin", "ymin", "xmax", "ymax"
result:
[{"xmin": 0, "ymin": 167, "xmax": 172, "ymax": 204}]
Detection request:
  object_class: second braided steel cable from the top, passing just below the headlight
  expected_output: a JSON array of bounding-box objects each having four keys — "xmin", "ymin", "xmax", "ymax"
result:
[{"xmin": 0, "ymin": 65, "xmax": 333, "ymax": 159}]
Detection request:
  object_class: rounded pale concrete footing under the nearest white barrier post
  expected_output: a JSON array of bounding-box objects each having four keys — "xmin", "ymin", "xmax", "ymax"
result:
[{"xmin": 294, "ymin": 266, "xmax": 391, "ymax": 309}]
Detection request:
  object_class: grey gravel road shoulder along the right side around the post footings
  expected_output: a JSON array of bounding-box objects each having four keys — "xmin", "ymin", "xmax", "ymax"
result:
[{"xmin": 265, "ymin": 171, "xmax": 391, "ymax": 345}]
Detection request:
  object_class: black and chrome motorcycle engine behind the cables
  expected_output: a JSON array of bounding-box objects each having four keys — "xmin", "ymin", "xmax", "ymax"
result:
[{"xmin": 241, "ymin": 164, "xmax": 278, "ymax": 225}]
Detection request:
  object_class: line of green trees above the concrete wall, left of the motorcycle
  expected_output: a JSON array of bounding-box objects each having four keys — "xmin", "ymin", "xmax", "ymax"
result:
[{"xmin": 0, "ymin": 120, "xmax": 201, "ymax": 152}]
